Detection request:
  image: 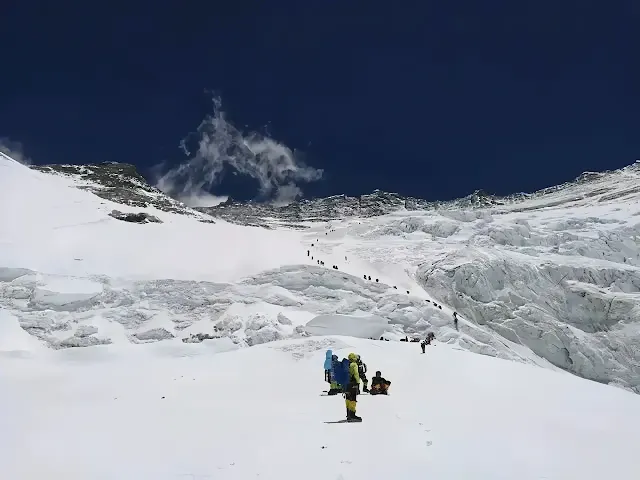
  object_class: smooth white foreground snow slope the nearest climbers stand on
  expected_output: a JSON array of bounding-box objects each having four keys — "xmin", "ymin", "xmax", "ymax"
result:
[{"xmin": 0, "ymin": 337, "xmax": 640, "ymax": 480}]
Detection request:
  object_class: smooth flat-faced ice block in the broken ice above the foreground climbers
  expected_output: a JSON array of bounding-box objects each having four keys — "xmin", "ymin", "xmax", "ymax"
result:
[{"xmin": 304, "ymin": 315, "xmax": 389, "ymax": 339}]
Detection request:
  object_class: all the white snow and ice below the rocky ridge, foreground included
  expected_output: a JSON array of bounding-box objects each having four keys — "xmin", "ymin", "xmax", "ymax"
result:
[{"xmin": 0, "ymin": 155, "xmax": 640, "ymax": 480}]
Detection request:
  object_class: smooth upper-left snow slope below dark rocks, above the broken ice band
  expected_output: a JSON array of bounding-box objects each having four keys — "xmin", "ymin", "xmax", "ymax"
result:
[{"xmin": 0, "ymin": 152, "xmax": 304, "ymax": 282}]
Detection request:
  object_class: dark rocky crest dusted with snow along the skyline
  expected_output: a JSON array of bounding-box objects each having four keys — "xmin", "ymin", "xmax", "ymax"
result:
[{"xmin": 32, "ymin": 160, "xmax": 640, "ymax": 228}]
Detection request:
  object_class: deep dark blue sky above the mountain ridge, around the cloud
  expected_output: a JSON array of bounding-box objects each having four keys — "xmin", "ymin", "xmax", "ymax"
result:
[{"xmin": 0, "ymin": 0, "xmax": 640, "ymax": 199}]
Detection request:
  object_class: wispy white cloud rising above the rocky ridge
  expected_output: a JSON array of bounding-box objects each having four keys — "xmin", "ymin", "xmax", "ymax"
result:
[{"xmin": 157, "ymin": 97, "xmax": 322, "ymax": 206}]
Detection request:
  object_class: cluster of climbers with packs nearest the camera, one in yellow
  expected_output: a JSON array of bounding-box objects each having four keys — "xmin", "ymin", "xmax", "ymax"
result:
[{"xmin": 324, "ymin": 350, "xmax": 391, "ymax": 422}]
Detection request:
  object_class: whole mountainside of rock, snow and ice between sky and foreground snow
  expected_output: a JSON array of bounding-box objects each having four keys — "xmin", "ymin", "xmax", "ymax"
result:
[{"xmin": 0, "ymin": 154, "xmax": 640, "ymax": 392}]
